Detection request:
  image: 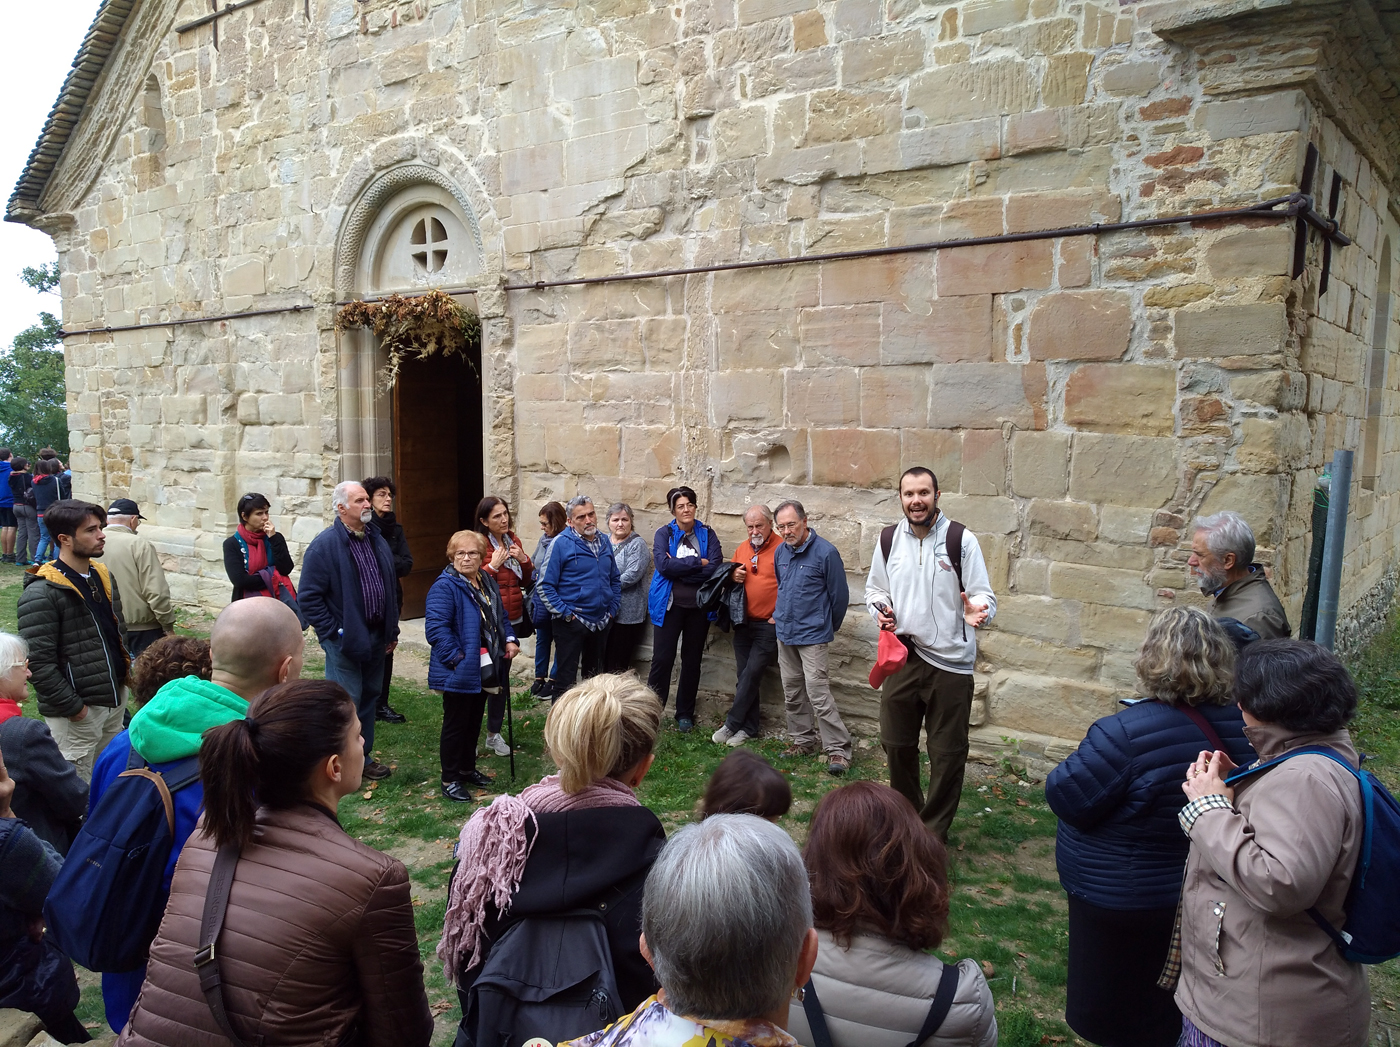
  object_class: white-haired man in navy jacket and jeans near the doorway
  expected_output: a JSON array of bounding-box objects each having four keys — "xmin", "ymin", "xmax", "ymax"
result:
[{"xmin": 297, "ymin": 480, "xmax": 399, "ymax": 781}]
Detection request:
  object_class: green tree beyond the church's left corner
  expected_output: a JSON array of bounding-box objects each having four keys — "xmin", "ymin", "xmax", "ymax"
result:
[{"xmin": 0, "ymin": 262, "xmax": 69, "ymax": 459}]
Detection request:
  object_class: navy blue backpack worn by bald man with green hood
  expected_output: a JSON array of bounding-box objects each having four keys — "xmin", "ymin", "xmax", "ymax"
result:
[{"xmin": 43, "ymin": 749, "xmax": 199, "ymax": 974}]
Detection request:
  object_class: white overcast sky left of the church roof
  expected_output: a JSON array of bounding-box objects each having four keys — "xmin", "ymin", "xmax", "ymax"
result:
[{"xmin": 0, "ymin": 0, "xmax": 98, "ymax": 347}]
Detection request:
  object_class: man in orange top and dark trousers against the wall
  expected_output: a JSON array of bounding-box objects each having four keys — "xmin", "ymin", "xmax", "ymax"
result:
[{"xmin": 710, "ymin": 505, "xmax": 783, "ymax": 746}]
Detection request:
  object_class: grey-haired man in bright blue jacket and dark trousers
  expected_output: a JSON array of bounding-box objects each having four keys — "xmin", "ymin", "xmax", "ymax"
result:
[{"xmin": 537, "ymin": 494, "xmax": 622, "ymax": 698}]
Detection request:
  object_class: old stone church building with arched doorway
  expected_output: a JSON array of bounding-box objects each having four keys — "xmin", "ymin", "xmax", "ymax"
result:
[{"xmin": 6, "ymin": 0, "xmax": 1400, "ymax": 754}]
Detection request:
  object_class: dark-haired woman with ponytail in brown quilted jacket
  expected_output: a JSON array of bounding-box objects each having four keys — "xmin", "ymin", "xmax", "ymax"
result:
[{"xmin": 119, "ymin": 680, "xmax": 433, "ymax": 1047}]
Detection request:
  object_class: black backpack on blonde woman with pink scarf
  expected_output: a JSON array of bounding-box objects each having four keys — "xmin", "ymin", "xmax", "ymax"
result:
[{"xmin": 454, "ymin": 908, "xmax": 622, "ymax": 1047}]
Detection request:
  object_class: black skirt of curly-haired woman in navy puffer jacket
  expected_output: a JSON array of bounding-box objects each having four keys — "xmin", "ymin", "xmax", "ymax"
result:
[{"xmin": 1064, "ymin": 894, "xmax": 1182, "ymax": 1047}]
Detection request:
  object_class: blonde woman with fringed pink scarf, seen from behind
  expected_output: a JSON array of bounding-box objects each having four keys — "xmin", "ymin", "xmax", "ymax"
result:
[{"xmin": 438, "ymin": 673, "xmax": 666, "ymax": 1037}]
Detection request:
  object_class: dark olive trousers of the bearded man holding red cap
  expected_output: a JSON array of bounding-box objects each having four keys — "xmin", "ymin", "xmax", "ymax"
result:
[{"xmin": 879, "ymin": 654, "xmax": 973, "ymax": 841}]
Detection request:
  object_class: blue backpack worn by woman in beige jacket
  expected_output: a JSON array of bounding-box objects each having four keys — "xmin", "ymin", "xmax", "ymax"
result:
[{"xmin": 1226, "ymin": 746, "xmax": 1400, "ymax": 963}]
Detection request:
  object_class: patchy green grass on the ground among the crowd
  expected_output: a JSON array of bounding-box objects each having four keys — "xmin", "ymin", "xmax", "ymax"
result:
[{"xmin": 8, "ymin": 568, "xmax": 1400, "ymax": 1047}]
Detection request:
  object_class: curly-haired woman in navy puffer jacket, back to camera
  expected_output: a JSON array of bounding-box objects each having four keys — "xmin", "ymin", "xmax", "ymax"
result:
[{"xmin": 1046, "ymin": 607, "xmax": 1254, "ymax": 1047}]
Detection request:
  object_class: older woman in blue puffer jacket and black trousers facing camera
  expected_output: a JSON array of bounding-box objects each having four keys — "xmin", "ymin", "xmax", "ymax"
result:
[{"xmin": 423, "ymin": 530, "xmax": 519, "ymax": 803}]
